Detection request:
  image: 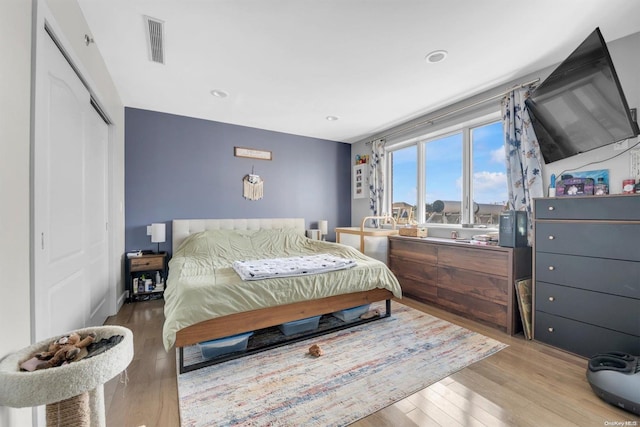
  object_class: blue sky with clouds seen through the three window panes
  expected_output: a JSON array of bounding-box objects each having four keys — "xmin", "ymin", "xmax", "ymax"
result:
[{"xmin": 393, "ymin": 122, "xmax": 507, "ymax": 206}]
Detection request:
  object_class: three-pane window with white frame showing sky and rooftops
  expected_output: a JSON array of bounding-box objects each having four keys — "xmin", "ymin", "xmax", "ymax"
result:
[{"xmin": 388, "ymin": 116, "xmax": 507, "ymax": 227}]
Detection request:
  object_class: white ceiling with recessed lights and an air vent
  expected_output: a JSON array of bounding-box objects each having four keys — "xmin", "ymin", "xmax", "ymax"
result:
[{"xmin": 78, "ymin": 0, "xmax": 640, "ymax": 143}]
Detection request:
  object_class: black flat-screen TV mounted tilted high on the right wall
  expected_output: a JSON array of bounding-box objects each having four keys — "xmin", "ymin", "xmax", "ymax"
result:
[{"xmin": 526, "ymin": 28, "xmax": 639, "ymax": 163}]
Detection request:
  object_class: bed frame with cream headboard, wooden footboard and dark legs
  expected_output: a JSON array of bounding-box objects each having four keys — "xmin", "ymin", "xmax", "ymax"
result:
[{"xmin": 172, "ymin": 218, "xmax": 393, "ymax": 373}]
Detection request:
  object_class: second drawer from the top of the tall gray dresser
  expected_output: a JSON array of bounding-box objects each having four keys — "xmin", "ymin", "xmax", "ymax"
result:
[{"xmin": 535, "ymin": 221, "xmax": 640, "ymax": 261}]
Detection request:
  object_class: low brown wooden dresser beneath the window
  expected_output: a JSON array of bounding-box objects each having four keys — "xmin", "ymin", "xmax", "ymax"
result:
[{"xmin": 389, "ymin": 236, "xmax": 531, "ymax": 335}]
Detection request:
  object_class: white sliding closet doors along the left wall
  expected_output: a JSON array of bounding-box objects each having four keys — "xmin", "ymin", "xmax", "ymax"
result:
[{"xmin": 33, "ymin": 31, "xmax": 108, "ymax": 341}]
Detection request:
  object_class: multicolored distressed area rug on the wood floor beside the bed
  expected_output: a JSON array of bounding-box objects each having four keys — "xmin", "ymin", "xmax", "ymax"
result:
[{"xmin": 178, "ymin": 303, "xmax": 507, "ymax": 427}]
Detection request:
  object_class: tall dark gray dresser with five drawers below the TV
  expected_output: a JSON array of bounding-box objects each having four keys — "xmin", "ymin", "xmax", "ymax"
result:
[{"xmin": 533, "ymin": 195, "xmax": 640, "ymax": 357}]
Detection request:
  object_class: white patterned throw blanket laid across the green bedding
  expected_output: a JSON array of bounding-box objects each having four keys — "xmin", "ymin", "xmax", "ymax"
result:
[{"xmin": 233, "ymin": 254, "xmax": 356, "ymax": 280}]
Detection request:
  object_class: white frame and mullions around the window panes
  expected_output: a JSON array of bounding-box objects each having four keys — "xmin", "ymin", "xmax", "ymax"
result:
[{"xmin": 383, "ymin": 109, "xmax": 502, "ymax": 228}]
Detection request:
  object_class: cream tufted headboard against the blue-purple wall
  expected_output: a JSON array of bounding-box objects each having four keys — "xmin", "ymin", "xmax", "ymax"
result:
[{"xmin": 171, "ymin": 218, "xmax": 305, "ymax": 251}]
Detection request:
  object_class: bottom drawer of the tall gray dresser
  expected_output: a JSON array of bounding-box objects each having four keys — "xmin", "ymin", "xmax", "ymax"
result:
[{"xmin": 534, "ymin": 311, "xmax": 640, "ymax": 357}]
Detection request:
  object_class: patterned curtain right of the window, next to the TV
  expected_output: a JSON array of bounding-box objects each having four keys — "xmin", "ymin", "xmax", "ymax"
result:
[{"xmin": 502, "ymin": 89, "xmax": 544, "ymax": 245}]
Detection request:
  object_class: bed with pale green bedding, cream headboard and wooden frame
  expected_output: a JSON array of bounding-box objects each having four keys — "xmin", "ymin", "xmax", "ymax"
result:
[{"xmin": 163, "ymin": 218, "xmax": 402, "ymax": 372}]
